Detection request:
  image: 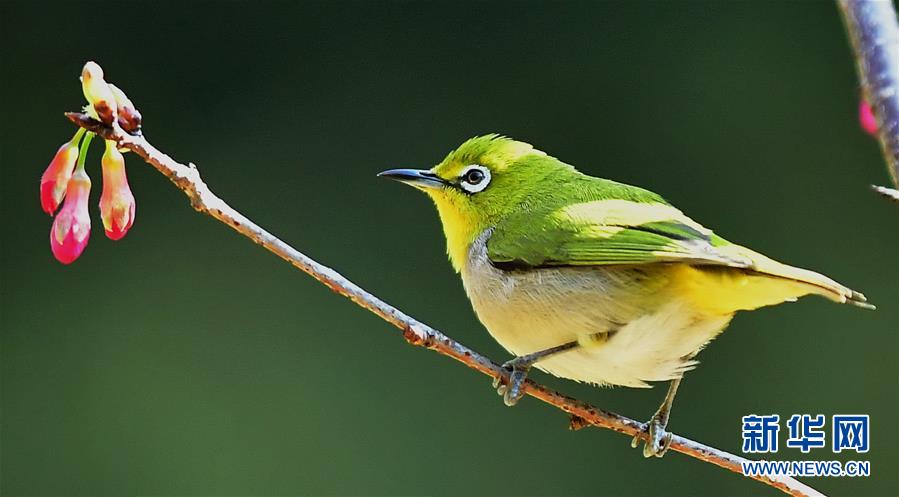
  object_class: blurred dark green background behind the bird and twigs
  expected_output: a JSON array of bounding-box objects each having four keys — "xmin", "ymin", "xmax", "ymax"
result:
[{"xmin": 0, "ymin": 2, "xmax": 899, "ymax": 496}]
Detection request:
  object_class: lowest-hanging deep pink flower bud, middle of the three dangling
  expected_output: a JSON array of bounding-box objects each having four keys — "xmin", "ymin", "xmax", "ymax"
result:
[{"xmin": 50, "ymin": 169, "xmax": 91, "ymax": 264}]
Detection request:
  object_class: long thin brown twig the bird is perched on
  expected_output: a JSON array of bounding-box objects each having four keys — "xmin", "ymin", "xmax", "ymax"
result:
[{"xmin": 66, "ymin": 112, "xmax": 822, "ymax": 497}]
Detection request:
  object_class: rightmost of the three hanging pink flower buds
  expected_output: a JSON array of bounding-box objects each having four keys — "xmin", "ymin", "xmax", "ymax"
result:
[{"xmin": 100, "ymin": 140, "xmax": 135, "ymax": 240}]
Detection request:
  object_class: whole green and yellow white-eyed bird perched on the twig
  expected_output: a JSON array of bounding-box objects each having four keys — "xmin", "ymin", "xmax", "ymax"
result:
[{"xmin": 379, "ymin": 135, "xmax": 873, "ymax": 457}]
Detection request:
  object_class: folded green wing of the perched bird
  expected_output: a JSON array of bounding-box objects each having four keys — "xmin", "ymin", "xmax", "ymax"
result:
[{"xmin": 487, "ymin": 199, "xmax": 753, "ymax": 268}]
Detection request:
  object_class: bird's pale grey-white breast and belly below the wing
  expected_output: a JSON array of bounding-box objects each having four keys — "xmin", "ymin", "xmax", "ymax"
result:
[{"xmin": 462, "ymin": 230, "xmax": 730, "ymax": 387}]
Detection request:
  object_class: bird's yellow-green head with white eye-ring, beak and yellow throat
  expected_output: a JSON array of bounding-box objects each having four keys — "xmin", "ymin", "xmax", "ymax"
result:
[{"xmin": 378, "ymin": 135, "xmax": 577, "ymax": 271}]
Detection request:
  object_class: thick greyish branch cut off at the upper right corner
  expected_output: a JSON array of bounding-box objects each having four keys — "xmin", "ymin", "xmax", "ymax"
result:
[{"xmin": 837, "ymin": 0, "xmax": 899, "ymax": 203}]
